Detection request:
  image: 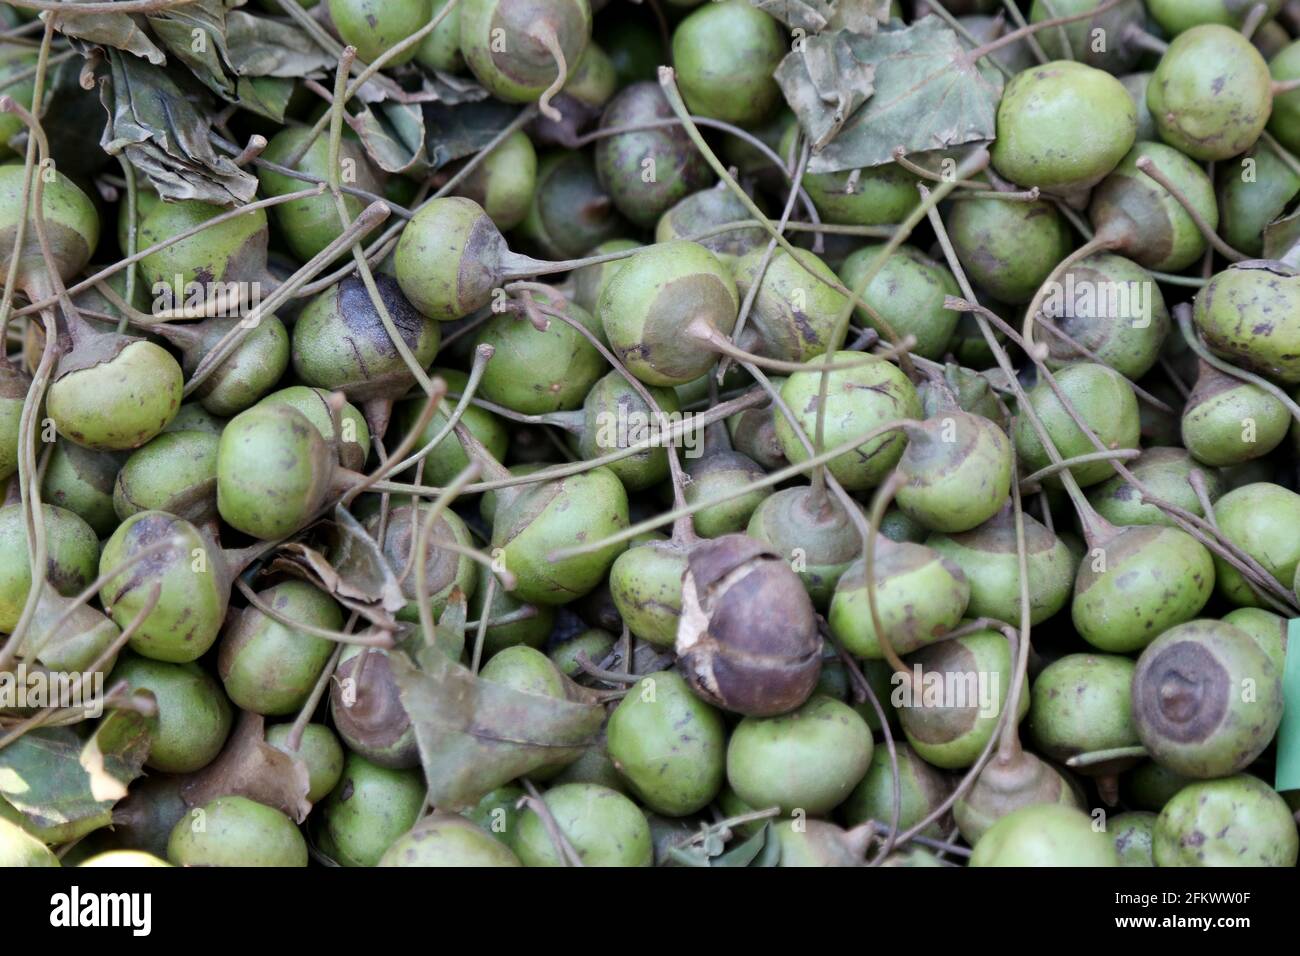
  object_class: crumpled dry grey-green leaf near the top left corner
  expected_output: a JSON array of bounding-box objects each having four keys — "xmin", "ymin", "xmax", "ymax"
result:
[{"xmin": 100, "ymin": 49, "xmax": 257, "ymax": 206}]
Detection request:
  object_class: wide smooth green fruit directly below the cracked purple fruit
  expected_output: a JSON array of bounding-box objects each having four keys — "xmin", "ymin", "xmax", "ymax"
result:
[{"xmin": 727, "ymin": 696, "xmax": 872, "ymax": 816}]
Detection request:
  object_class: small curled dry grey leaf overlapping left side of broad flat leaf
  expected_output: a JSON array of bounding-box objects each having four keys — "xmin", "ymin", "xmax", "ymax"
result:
[{"xmin": 776, "ymin": 30, "xmax": 876, "ymax": 153}]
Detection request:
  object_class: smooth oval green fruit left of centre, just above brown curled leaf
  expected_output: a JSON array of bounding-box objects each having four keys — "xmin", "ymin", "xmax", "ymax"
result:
[{"xmin": 217, "ymin": 405, "xmax": 335, "ymax": 540}]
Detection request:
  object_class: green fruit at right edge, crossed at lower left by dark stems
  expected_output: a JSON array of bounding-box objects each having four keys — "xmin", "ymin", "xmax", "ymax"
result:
[{"xmin": 1214, "ymin": 481, "xmax": 1300, "ymax": 607}]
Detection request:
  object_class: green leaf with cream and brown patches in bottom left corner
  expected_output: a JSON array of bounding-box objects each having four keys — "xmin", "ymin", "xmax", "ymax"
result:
[{"xmin": 0, "ymin": 710, "xmax": 152, "ymax": 836}]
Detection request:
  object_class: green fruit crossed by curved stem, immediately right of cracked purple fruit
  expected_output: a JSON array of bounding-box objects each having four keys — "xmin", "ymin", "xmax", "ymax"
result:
[{"xmin": 827, "ymin": 542, "xmax": 971, "ymax": 659}]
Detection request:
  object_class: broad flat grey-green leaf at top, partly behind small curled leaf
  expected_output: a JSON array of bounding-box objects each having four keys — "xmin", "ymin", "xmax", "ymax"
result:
[{"xmin": 777, "ymin": 17, "xmax": 1002, "ymax": 173}]
